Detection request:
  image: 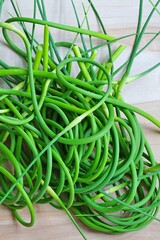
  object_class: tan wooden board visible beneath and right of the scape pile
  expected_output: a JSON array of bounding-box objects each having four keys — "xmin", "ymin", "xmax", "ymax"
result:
[{"xmin": 0, "ymin": 101, "xmax": 160, "ymax": 240}]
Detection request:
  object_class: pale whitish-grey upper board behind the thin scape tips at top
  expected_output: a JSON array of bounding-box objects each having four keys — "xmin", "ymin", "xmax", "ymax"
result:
[{"xmin": 0, "ymin": 0, "xmax": 160, "ymax": 103}]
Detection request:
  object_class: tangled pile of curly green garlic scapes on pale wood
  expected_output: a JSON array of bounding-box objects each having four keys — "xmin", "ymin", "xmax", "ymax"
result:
[{"xmin": 0, "ymin": 1, "xmax": 160, "ymax": 238}]
